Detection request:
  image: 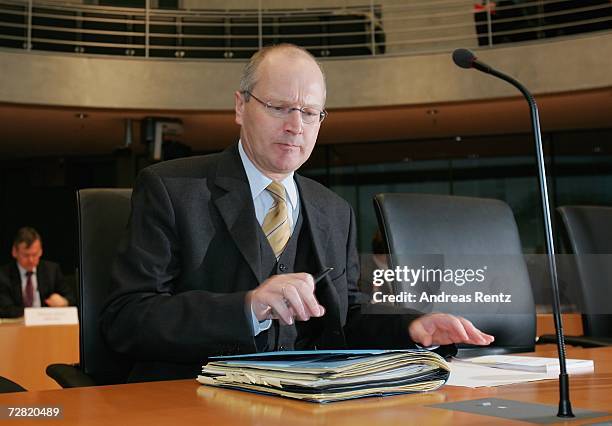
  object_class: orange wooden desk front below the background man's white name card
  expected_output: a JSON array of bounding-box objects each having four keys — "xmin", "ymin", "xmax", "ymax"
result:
[{"xmin": 0, "ymin": 322, "xmax": 79, "ymax": 390}]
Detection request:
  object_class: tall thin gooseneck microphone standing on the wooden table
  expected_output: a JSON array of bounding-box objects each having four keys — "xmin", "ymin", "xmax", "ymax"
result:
[{"xmin": 453, "ymin": 49, "xmax": 575, "ymax": 417}]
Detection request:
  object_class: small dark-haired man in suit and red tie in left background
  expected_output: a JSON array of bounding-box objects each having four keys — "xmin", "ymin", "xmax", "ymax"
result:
[{"xmin": 0, "ymin": 227, "xmax": 75, "ymax": 318}]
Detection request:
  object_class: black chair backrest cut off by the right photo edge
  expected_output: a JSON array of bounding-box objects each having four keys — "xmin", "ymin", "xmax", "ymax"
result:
[{"xmin": 557, "ymin": 206, "xmax": 612, "ymax": 337}]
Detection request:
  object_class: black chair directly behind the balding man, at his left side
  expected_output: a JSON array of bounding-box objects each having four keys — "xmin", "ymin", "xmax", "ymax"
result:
[{"xmin": 47, "ymin": 189, "xmax": 132, "ymax": 388}]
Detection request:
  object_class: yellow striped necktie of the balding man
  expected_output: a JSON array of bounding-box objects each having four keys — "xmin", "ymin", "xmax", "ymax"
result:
[{"xmin": 261, "ymin": 182, "xmax": 291, "ymax": 259}]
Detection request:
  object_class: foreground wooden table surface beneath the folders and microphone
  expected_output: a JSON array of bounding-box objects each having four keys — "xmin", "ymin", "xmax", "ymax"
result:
[{"xmin": 0, "ymin": 347, "xmax": 612, "ymax": 426}]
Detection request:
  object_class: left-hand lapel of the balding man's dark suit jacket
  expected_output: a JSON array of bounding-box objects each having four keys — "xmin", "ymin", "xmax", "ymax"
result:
[{"xmin": 214, "ymin": 145, "xmax": 263, "ymax": 283}]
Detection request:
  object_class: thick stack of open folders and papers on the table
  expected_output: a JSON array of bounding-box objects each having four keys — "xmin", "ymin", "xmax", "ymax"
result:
[{"xmin": 197, "ymin": 349, "xmax": 450, "ymax": 402}]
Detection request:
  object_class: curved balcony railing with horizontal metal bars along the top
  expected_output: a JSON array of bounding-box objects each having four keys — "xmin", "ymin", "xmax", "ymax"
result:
[{"xmin": 0, "ymin": 0, "xmax": 612, "ymax": 60}]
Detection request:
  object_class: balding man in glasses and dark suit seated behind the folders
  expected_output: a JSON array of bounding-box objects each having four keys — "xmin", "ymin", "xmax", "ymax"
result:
[{"xmin": 101, "ymin": 45, "xmax": 493, "ymax": 381}]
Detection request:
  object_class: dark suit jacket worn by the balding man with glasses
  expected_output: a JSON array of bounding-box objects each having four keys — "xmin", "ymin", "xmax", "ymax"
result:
[{"xmin": 101, "ymin": 145, "xmax": 418, "ymax": 379}]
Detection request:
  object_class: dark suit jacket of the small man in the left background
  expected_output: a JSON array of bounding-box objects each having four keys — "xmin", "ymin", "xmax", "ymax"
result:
[{"xmin": 0, "ymin": 259, "xmax": 76, "ymax": 318}]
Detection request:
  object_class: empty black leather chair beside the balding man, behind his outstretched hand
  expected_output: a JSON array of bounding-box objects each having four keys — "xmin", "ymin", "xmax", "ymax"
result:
[{"xmin": 374, "ymin": 193, "xmax": 536, "ymax": 356}]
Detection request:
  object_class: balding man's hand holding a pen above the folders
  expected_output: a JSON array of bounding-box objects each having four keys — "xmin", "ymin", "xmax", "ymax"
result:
[{"xmin": 246, "ymin": 273, "xmax": 325, "ymax": 324}]
